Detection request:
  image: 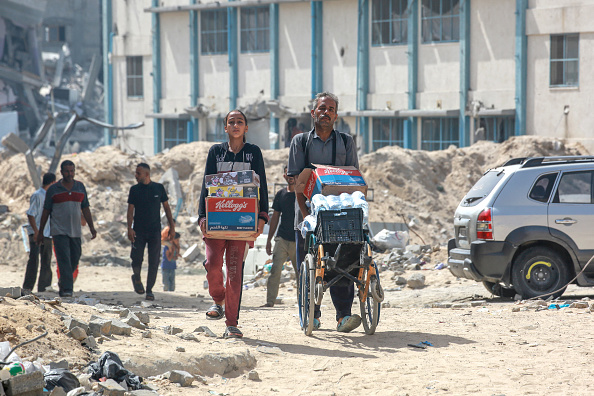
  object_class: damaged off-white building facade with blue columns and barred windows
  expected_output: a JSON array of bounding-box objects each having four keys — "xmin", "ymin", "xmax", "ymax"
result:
[{"xmin": 103, "ymin": 0, "xmax": 594, "ymax": 154}]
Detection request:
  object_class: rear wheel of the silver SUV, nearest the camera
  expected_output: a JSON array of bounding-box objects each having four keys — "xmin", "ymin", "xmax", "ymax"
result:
[{"xmin": 512, "ymin": 247, "xmax": 570, "ymax": 299}]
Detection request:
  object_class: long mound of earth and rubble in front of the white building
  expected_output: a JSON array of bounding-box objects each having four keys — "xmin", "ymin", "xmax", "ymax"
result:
[{"xmin": 0, "ymin": 136, "xmax": 587, "ymax": 276}]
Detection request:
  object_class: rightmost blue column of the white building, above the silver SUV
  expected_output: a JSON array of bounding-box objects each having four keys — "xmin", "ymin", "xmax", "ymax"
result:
[{"xmin": 515, "ymin": 0, "xmax": 528, "ymax": 136}]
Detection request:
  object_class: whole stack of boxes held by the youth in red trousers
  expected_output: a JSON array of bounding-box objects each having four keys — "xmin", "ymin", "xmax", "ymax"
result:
[{"xmin": 204, "ymin": 170, "xmax": 260, "ymax": 241}]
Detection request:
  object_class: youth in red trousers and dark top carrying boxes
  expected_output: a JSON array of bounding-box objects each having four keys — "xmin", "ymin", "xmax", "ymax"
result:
[{"xmin": 198, "ymin": 110, "xmax": 268, "ymax": 338}]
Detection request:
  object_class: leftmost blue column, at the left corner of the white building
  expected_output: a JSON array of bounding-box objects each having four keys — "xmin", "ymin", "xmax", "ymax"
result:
[{"xmin": 101, "ymin": 0, "xmax": 113, "ymax": 145}]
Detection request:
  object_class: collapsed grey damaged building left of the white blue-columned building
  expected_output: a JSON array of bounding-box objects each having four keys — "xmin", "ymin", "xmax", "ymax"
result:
[{"xmin": 0, "ymin": 0, "xmax": 104, "ymax": 156}]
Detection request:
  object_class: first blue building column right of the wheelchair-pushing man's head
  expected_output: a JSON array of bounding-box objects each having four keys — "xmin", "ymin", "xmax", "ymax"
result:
[{"xmin": 357, "ymin": 0, "xmax": 369, "ymax": 153}]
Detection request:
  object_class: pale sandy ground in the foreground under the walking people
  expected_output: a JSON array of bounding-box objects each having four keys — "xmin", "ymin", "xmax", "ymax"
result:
[{"xmin": 0, "ymin": 256, "xmax": 594, "ymax": 395}]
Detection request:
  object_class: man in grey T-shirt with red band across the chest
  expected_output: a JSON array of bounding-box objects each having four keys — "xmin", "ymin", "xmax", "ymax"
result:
[{"xmin": 37, "ymin": 160, "xmax": 97, "ymax": 297}]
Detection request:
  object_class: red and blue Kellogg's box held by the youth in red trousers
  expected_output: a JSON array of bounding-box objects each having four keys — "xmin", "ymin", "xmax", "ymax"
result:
[{"xmin": 206, "ymin": 197, "xmax": 258, "ymax": 240}]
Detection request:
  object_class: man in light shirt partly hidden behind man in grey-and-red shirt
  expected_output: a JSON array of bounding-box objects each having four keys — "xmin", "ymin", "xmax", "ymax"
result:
[{"xmin": 23, "ymin": 173, "xmax": 56, "ymax": 294}]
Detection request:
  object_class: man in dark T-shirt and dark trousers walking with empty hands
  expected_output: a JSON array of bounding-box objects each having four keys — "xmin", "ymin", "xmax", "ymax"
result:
[{"xmin": 127, "ymin": 162, "xmax": 175, "ymax": 301}]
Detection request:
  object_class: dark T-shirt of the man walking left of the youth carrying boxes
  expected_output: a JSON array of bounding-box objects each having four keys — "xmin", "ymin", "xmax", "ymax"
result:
[{"xmin": 128, "ymin": 181, "xmax": 169, "ymax": 234}]
